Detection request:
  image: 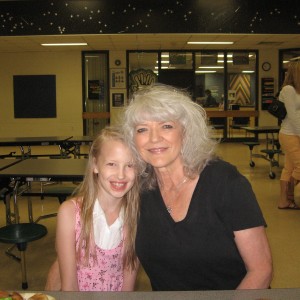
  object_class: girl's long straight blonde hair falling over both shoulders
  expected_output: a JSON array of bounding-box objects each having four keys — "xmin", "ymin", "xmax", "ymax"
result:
[{"xmin": 75, "ymin": 127, "xmax": 139, "ymax": 268}]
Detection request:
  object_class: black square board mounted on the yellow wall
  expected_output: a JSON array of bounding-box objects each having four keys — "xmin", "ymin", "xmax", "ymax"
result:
[{"xmin": 13, "ymin": 75, "xmax": 56, "ymax": 118}]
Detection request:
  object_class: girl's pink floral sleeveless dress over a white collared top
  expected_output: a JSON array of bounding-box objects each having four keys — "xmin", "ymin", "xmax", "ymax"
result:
[{"xmin": 75, "ymin": 203, "xmax": 123, "ymax": 291}]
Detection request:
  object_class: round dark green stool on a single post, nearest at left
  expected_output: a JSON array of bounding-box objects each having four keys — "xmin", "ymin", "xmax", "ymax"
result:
[{"xmin": 0, "ymin": 223, "xmax": 47, "ymax": 290}]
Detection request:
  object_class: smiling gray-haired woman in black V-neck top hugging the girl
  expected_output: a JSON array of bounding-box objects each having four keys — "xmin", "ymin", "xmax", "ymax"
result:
[{"xmin": 124, "ymin": 85, "xmax": 272, "ymax": 290}]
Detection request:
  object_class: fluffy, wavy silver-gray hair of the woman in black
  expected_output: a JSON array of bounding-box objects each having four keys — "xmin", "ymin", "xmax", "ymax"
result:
[{"xmin": 123, "ymin": 84, "xmax": 217, "ymax": 188}]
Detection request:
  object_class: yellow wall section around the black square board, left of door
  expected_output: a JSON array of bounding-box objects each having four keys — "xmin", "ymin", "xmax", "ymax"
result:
[{"xmin": 0, "ymin": 51, "xmax": 83, "ymax": 137}]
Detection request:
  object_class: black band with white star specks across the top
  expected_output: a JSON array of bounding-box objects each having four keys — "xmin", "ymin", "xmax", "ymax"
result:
[{"xmin": 0, "ymin": 0, "xmax": 300, "ymax": 36}]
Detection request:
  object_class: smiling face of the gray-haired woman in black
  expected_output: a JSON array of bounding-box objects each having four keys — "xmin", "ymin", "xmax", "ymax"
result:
[{"xmin": 134, "ymin": 121, "xmax": 182, "ymax": 168}]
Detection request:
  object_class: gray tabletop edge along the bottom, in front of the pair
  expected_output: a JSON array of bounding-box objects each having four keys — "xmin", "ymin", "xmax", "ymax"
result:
[{"xmin": 29, "ymin": 289, "xmax": 300, "ymax": 300}]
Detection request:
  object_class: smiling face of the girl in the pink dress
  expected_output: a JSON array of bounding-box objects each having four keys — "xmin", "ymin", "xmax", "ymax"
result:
[{"xmin": 94, "ymin": 140, "xmax": 136, "ymax": 199}]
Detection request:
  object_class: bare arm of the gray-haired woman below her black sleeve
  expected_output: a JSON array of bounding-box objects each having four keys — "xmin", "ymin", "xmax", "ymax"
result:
[{"xmin": 234, "ymin": 226, "xmax": 273, "ymax": 289}]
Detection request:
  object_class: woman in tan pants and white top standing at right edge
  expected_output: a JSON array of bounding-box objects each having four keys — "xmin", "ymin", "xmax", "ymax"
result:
[{"xmin": 278, "ymin": 61, "xmax": 300, "ymax": 210}]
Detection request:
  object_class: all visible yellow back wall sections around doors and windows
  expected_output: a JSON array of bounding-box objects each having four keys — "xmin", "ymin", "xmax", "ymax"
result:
[{"xmin": 0, "ymin": 50, "xmax": 278, "ymax": 137}]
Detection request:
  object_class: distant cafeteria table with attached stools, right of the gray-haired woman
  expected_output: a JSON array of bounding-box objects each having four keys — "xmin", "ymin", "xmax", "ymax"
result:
[{"xmin": 242, "ymin": 126, "xmax": 282, "ymax": 179}]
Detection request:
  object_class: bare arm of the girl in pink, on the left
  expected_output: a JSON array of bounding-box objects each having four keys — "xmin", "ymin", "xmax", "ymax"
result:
[{"xmin": 56, "ymin": 200, "xmax": 78, "ymax": 291}]
